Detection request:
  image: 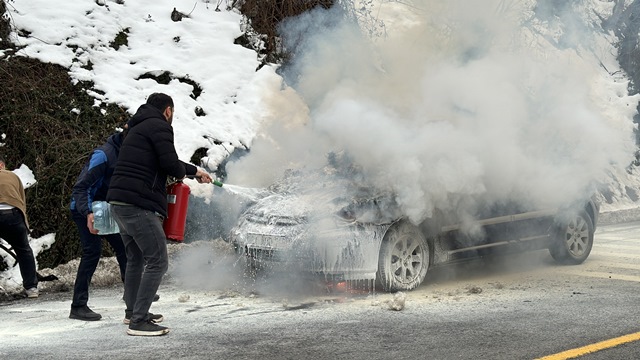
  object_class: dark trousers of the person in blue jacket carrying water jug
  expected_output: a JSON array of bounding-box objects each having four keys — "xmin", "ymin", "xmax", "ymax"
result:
[{"xmin": 71, "ymin": 210, "xmax": 127, "ymax": 307}]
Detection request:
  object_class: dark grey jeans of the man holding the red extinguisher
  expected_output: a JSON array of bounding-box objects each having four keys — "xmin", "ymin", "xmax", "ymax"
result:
[{"xmin": 111, "ymin": 204, "xmax": 169, "ymax": 323}]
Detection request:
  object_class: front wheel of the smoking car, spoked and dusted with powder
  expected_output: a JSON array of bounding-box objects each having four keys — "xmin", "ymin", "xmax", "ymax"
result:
[{"xmin": 376, "ymin": 221, "xmax": 430, "ymax": 292}]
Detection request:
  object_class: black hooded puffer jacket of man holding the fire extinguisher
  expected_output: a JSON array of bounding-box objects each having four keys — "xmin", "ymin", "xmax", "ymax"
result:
[{"xmin": 107, "ymin": 104, "xmax": 198, "ymax": 217}]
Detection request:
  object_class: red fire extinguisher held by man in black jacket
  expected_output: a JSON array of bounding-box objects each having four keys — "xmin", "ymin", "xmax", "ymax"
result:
[{"xmin": 162, "ymin": 181, "xmax": 191, "ymax": 241}]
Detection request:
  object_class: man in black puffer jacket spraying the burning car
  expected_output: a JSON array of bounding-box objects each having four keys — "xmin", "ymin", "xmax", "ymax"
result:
[{"xmin": 107, "ymin": 93, "xmax": 212, "ymax": 336}]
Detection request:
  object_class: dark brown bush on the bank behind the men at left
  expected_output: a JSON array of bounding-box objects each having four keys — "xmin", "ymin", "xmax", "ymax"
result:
[{"xmin": 0, "ymin": 56, "xmax": 128, "ymax": 268}]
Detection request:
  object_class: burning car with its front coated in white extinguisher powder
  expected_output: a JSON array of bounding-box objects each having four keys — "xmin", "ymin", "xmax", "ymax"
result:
[{"xmin": 230, "ymin": 157, "xmax": 599, "ymax": 292}]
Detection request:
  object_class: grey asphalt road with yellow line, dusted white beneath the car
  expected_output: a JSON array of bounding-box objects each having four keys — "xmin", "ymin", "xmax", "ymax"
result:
[{"xmin": 0, "ymin": 222, "xmax": 640, "ymax": 360}]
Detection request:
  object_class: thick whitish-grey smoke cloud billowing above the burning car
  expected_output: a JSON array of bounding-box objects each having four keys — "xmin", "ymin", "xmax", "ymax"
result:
[{"xmin": 227, "ymin": 0, "xmax": 635, "ymax": 223}]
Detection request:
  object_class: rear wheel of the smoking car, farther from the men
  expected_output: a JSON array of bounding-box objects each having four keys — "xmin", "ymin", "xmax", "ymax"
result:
[{"xmin": 549, "ymin": 211, "xmax": 594, "ymax": 265}]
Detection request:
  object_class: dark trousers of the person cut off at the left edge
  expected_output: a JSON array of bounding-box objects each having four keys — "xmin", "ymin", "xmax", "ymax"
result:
[{"xmin": 0, "ymin": 208, "xmax": 38, "ymax": 289}]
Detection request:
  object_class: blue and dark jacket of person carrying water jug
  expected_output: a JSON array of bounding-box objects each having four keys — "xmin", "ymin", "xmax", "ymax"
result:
[{"xmin": 71, "ymin": 132, "xmax": 123, "ymax": 217}]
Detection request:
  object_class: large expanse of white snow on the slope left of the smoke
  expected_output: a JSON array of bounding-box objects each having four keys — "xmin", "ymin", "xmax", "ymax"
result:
[{"xmin": 8, "ymin": 1, "xmax": 280, "ymax": 168}]
